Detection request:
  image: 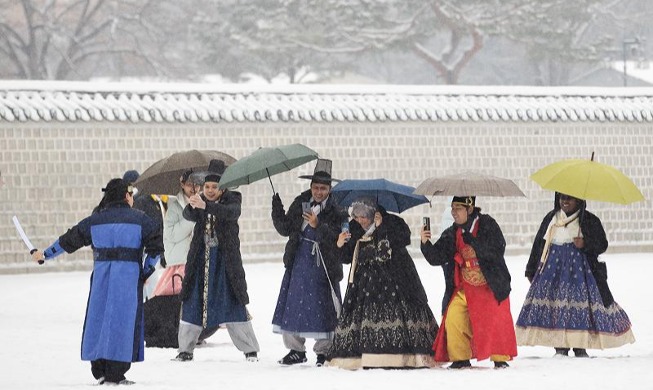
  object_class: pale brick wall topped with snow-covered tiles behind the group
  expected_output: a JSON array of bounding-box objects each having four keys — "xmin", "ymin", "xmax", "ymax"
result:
[{"xmin": 0, "ymin": 82, "xmax": 653, "ymax": 272}]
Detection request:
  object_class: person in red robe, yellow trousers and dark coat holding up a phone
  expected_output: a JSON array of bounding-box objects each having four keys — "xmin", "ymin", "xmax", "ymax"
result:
[{"xmin": 420, "ymin": 196, "xmax": 517, "ymax": 369}]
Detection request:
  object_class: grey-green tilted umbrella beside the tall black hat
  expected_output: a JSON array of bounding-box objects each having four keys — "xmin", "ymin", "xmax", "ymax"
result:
[{"xmin": 220, "ymin": 144, "xmax": 318, "ymax": 192}]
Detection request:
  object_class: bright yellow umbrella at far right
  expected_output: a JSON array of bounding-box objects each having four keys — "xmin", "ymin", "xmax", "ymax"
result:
[{"xmin": 531, "ymin": 152, "xmax": 644, "ymax": 204}]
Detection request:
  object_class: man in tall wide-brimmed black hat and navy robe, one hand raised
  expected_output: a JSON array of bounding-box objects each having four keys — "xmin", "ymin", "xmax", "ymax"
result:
[{"xmin": 272, "ymin": 159, "xmax": 347, "ymax": 366}]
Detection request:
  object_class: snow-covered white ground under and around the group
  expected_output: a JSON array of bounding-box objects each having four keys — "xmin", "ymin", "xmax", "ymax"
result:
[{"xmin": 0, "ymin": 253, "xmax": 653, "ymax": 390}]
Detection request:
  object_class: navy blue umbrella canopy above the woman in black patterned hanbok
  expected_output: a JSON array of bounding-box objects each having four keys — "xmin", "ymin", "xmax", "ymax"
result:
[{"xmin": 331, "ymin": 179, "xmax": 429, "ymax": 213}]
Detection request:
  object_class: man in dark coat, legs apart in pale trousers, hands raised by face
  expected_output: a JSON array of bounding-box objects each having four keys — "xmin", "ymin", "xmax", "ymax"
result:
[{"xmin": 175, "ymin": 160, "xmax": 259, "ymax": 362}]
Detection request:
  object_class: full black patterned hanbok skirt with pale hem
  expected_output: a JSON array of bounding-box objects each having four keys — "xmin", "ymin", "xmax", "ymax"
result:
[{"xmin": 328, "ymin": 261, "xmax": 438, "ymax": 369}]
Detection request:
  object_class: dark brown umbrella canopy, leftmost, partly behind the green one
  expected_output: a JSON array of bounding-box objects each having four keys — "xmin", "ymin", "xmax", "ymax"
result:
[{"xmin": 134, "ymin": 150, "xmax": 236, "ymax": 195}]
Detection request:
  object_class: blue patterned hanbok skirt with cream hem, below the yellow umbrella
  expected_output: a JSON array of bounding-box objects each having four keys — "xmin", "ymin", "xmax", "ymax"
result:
[{"xmin": 516, "ymin": 243, "xmax": 635, "ymax": 349}]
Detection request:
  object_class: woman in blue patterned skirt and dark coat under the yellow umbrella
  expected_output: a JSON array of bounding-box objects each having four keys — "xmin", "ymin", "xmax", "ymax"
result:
[{"xmin": 516, "ymin": 192, "xmax": 635, "ymax": 357}]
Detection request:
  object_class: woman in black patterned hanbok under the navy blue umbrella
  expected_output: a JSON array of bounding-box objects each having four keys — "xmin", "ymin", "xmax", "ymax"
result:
[{"xmin": 328, "ymin": 200, "xmax": 438, "ymax": 369}]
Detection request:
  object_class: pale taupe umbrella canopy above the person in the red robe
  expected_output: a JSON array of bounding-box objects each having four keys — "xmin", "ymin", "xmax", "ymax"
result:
[{"xmin": 415, "ymin": 171, "xmax": 526, "ymax": 196}]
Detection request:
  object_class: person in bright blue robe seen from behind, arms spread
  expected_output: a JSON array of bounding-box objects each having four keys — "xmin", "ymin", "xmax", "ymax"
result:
[{"xmin": 32, "ymin": 179, "xmax": 163, "ymax": 384}]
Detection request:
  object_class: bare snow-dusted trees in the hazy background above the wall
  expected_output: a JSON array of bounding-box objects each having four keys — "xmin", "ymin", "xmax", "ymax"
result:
[{"xmin": 0, "ymin": 0, "xmax": 653, "ymax": 85}]
